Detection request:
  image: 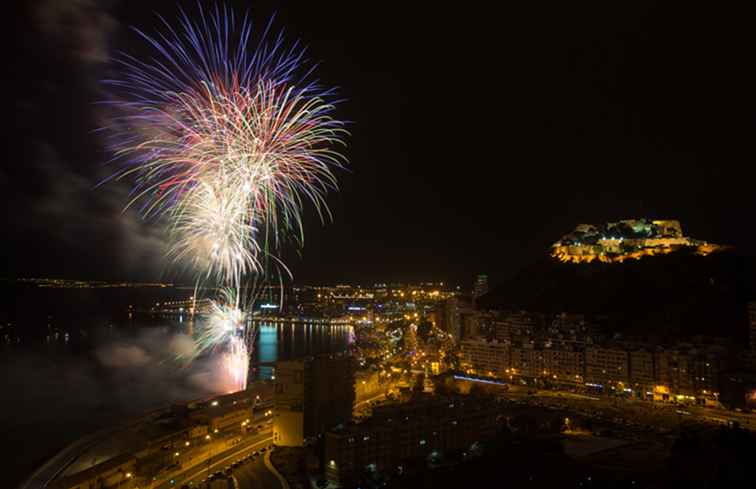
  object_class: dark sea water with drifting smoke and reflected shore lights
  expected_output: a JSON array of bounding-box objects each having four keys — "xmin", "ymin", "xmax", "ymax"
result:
[{"xmin": 0, "ymin": 287, "xmax": 352, "ymax": 488}]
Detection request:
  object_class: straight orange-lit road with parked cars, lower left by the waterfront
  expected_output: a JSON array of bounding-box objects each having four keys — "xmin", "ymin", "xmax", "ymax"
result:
[{"xmin": 151, "ymin": 430, "xmax": 280, "ymax": 489}]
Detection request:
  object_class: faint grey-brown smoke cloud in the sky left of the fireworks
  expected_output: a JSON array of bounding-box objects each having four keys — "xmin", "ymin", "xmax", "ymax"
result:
[{"xmin": 5, "ymin": 0, "xmax": 170, "ymax": 280}]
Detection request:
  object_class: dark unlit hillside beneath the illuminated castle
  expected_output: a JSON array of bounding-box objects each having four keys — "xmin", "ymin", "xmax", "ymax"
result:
[{"xmin": 479, "ymin": 249, "xmax": 756, "ymax": 340}]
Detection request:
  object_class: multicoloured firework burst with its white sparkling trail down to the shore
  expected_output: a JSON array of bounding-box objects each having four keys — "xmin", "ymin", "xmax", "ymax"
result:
[{"xmin": 103, "ymin": 6, "xmax": 347, "ymax": 385}]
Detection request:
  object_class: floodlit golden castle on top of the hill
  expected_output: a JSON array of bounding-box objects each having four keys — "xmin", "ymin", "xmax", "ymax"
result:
[{"xmin": 551, "ymin": 219, "xmax": 722, "ymax": 263}]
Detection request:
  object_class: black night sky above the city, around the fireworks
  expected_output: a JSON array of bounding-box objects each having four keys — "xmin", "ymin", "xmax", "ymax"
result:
[{"xmin": 5, "ymin": 0, "xmax": 756, "ymax": 285}]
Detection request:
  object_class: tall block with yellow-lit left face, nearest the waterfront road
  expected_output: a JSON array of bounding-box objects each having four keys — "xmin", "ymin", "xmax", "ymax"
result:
[{"xmin": 273, "ymin": 354, "xmax": 355, "ymax": 446}]
